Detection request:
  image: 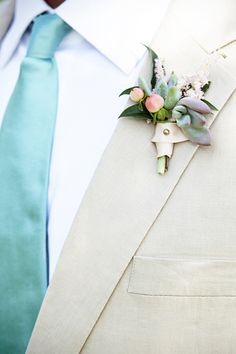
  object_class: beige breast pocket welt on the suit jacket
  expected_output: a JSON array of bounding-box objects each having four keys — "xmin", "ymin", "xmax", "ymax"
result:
[{"xmin": 128, "ymin": 256, "xmax": 236, "ymax": 297}]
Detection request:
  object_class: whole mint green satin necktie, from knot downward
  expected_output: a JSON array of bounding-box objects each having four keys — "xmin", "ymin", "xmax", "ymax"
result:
[{"xmin": 0, "ymin": 14, "xmax": 71, "ymax": 354}]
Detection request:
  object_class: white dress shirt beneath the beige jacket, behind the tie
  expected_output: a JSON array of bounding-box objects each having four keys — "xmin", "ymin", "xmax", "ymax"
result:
[{"xmin": 0, "ymin": 0, "xmax": 168, "ymax": 278}]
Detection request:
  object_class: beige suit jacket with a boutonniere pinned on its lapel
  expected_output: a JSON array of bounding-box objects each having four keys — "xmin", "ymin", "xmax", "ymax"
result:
[{"xmin": 27, "ymin": 0, "xmax": 236, "ymax": 354}]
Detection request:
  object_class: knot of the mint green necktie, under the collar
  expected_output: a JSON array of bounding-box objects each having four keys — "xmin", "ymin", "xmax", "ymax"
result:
[{"xmin": 27, "ymin": 13, "xmax": 71, "ymax": 59}]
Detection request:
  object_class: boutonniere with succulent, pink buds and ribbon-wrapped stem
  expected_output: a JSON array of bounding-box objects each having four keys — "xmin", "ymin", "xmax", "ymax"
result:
[{"xmin": 119, "ymin": 47, "xmax": 216, "ymax": 175}]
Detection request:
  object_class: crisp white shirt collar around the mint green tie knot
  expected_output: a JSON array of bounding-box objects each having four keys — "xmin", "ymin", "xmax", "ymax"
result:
[{"xmin": 0, "ymin": 0, "xmax": 170, "ymax": 73}]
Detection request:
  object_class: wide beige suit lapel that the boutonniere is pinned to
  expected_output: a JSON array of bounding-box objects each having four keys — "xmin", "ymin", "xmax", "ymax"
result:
[{"xmin": 28, "ymin": 20, "xmax": 236, "ymax": 354}]
